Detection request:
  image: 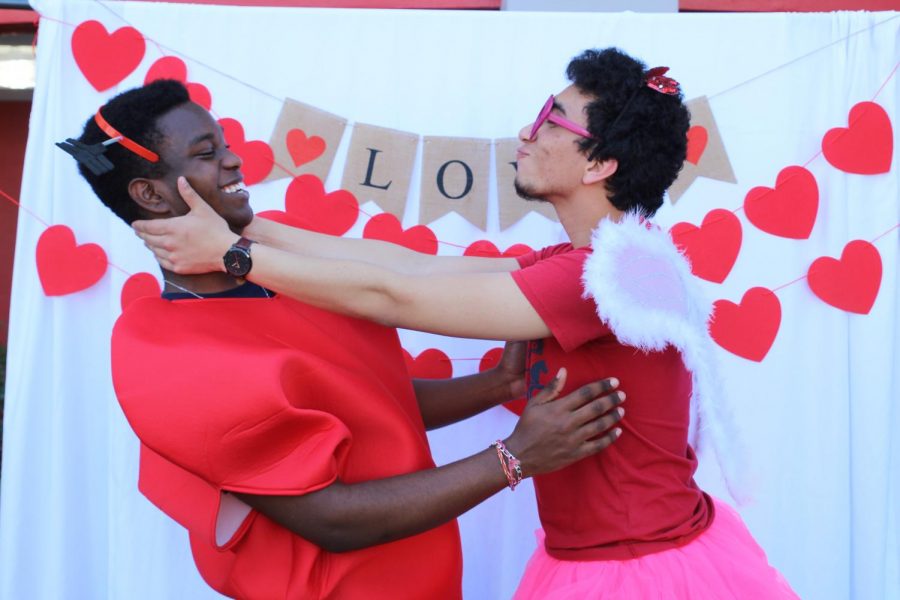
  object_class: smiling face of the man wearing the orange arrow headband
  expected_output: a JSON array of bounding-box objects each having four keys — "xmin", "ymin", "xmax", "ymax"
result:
[{"xmin": 146, "ymin": 102, "xmax": 253, "ymax": 232}]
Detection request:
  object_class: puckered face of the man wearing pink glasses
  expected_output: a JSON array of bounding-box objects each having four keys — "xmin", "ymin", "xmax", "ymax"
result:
[{"xmin": 515, "ymin": 85, "xmax": 593, "ymax": 202}]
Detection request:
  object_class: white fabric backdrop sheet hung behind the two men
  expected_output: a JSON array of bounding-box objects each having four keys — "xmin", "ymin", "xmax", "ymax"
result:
[{"xmin": 0, "ymin": 0, "xmax": 900, "ymax": 600}]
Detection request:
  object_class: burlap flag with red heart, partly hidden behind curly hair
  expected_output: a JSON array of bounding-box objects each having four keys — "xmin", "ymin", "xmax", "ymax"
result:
[{"xmin": 669, "ymin": 96, "xmax": 737, "ymax": 204}]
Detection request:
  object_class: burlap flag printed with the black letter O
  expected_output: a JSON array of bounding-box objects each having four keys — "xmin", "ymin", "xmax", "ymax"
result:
[{"xmin": 419, "ymin": 137, "xmax": 491, "ymax": 231}]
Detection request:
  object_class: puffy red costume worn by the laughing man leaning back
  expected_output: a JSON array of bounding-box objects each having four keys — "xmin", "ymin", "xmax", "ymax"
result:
[{"xmin": 112, "ymin": 297, "xmax": 462, "ymax": 600}]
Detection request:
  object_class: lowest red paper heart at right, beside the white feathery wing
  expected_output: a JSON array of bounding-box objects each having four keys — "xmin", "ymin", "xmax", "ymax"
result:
[{"xmin": 709, "ymin": 287, "xmax": 781, "ymax": 362}]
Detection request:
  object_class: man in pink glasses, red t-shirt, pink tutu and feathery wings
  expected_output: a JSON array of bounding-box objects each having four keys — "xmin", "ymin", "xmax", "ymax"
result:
[{"xmin": 141, "ymin": 48, "xmax": 795, "ymax": 600}]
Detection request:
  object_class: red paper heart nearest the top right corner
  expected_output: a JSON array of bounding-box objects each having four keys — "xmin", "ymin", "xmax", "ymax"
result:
[{"xmin": 822, "ymin": 102, "xmax": 894, "ymax": 175}]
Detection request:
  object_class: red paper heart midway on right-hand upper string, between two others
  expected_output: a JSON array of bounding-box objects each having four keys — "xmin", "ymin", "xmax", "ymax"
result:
[{"xmin": 744, "ymin": 167, "xmax": 819, "ymax": 240}]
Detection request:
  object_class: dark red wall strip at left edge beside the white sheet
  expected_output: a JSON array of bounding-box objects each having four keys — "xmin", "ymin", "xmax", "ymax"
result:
[{"xmin": 0, "ymin": 102, "xmax": 31, "ymax": 346}]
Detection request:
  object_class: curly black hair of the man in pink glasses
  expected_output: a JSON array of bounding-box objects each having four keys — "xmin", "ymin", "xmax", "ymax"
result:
[{"xmin": 566, "ymin": 48, "xmax": 690, "ymax": 216}]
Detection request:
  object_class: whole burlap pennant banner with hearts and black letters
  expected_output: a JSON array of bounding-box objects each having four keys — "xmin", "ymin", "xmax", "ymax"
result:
[{"xmin": 266, "ymin": 96, "xmax": 724, "ymax": 226}]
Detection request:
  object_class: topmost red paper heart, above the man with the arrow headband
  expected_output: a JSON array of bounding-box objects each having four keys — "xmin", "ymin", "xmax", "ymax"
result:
[{"xmin": 72, "ymin": 21, "xmax": 146, "ymax": 92}]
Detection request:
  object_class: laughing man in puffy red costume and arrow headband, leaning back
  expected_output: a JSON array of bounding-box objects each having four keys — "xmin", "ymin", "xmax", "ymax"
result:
[{"xmin": 60, "ymin": 81, "xmax": 624, "ymax": 599}]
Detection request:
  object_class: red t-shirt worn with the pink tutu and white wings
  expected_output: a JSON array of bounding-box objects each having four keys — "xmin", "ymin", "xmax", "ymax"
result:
[{"xmin": 512, "ymin": 244, "xmax": 713, "ymax": 560}]
